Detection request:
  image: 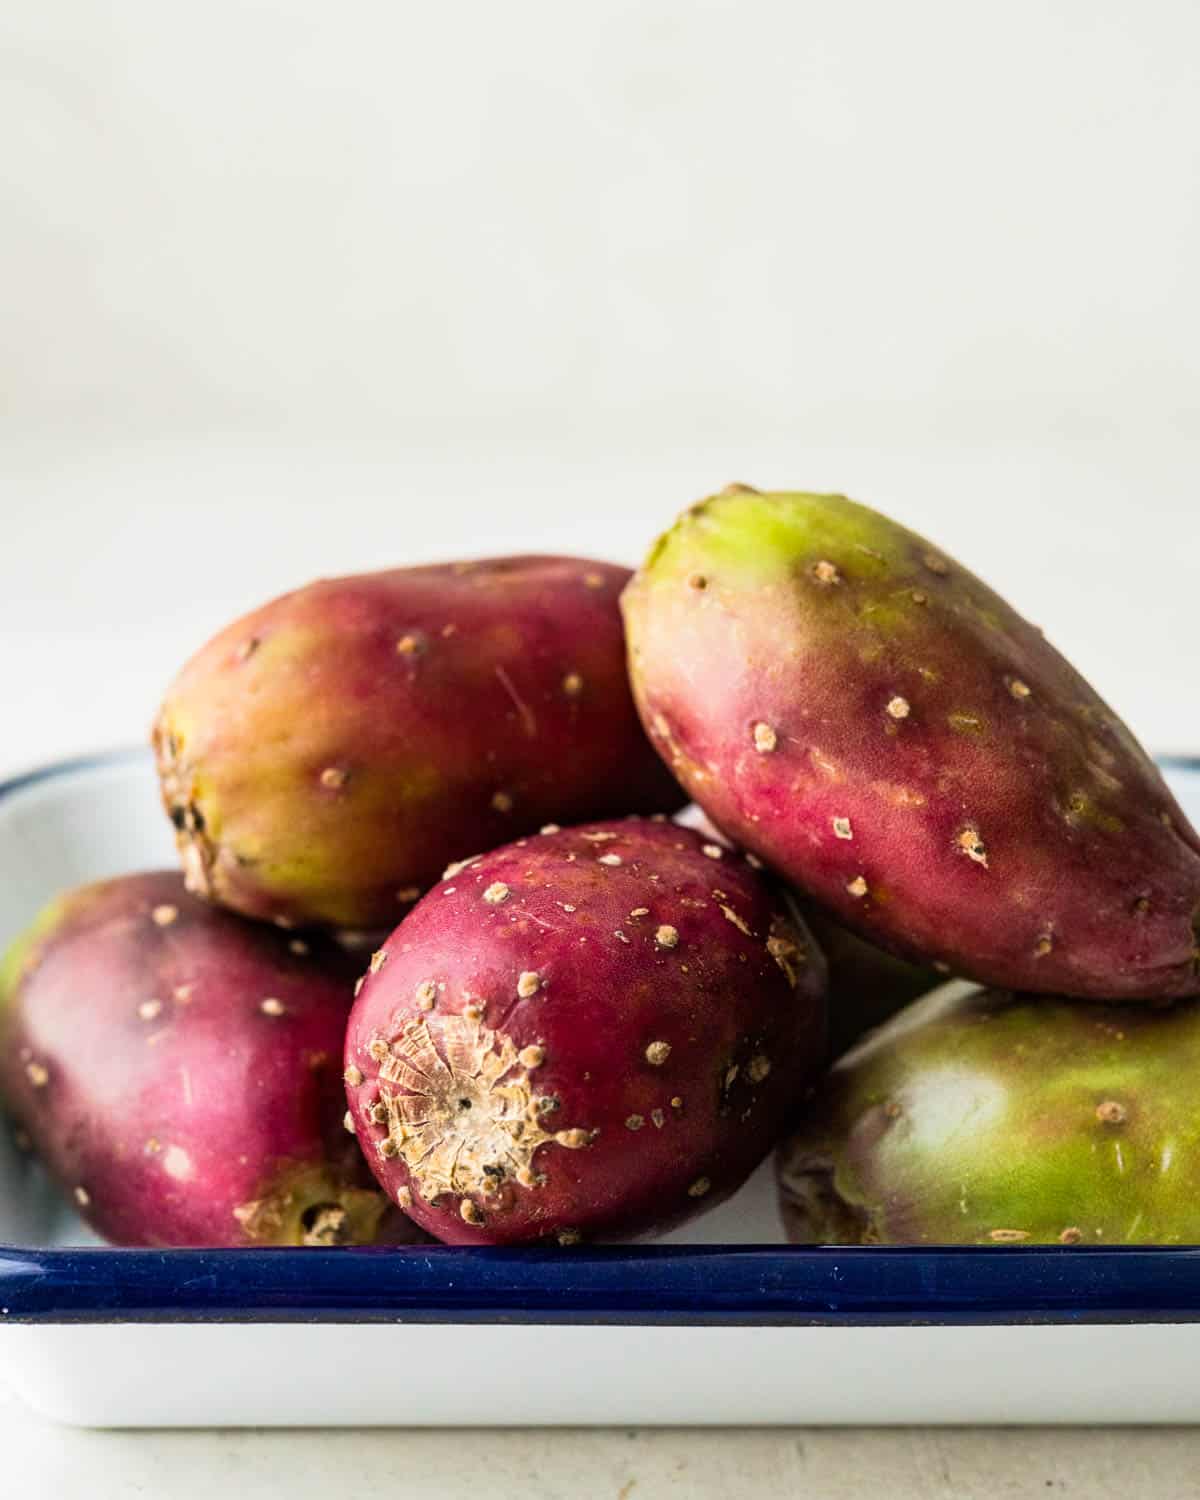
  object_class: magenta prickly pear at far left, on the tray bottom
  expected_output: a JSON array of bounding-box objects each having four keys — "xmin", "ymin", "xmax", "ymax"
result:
[{"xmin": 0, "ymin": 872, "xmax": 420, "ymax": 1247}]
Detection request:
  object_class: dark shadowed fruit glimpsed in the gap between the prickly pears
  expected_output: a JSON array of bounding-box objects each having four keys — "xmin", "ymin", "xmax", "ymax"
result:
[{"xmin": 792, "ymin": 896, "xmax": 945, "ymax": 1058}]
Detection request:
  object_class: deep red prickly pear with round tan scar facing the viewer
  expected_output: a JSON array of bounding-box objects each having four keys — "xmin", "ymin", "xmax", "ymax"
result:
[{"xmin": 347, "ymin": 819, "xmax": 825, "ymax": 1245}]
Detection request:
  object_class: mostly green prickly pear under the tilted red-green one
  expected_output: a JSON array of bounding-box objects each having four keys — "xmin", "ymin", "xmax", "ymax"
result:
[{"xmin": 777, "ymin": 986, "xmax": 1200, "ymax": 1245}]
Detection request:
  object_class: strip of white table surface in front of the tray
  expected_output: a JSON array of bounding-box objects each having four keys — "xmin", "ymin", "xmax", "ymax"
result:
[{"xmin": 0, "ymin": 1374, "xmax": 1200, "ymax": 1500}]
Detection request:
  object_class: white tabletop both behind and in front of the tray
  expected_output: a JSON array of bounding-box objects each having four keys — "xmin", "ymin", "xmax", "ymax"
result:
[{"xmin": 0, "ymin": 435, "xmax": 1200, "ymax": 1500}]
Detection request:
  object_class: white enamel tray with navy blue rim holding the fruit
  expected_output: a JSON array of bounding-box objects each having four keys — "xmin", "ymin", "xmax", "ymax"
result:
[{"xmin": 0, "ymin": 752, "xmax": 1200, "ymax": 1427}]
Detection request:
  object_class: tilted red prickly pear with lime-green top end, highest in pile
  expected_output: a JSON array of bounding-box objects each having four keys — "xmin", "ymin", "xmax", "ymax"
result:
[{"xmin": 623, "ymin": 488, "xmax": 1200, "ymax": 999}]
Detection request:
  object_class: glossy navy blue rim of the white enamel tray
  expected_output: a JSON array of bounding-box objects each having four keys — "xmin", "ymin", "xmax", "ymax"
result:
[{"xmin": 0, "ymin": 747, "xmax": 1200, "ymax": 1326}]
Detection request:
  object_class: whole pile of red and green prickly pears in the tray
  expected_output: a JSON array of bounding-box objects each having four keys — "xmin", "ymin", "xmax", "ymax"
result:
[{"xmin": 0, "ymin": 485, "xmax": 1200, "ymax": 1247}]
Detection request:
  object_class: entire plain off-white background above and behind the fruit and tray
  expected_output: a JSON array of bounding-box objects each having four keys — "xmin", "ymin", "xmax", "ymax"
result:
[{"xmin": 0, "ymin": 0, "xmax": 1200, "ymax": 773}]
